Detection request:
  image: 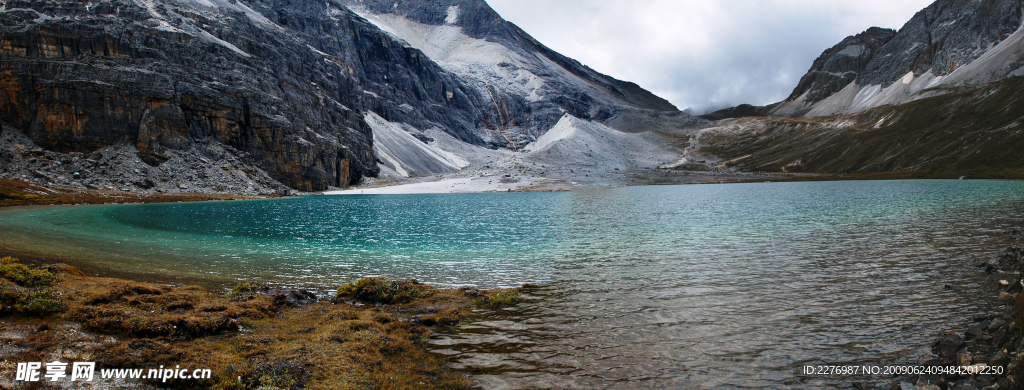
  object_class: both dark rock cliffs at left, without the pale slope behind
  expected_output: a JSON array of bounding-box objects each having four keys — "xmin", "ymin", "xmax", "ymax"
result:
[{"xmin": 0, "ymin": 0, "xmax": 524, "ymax": 190}]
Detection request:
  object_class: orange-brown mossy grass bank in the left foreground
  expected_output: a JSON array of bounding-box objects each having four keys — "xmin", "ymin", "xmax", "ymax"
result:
[{"xmin": 0, "ymin": 258, "xmax": 518, "ymax": 390}]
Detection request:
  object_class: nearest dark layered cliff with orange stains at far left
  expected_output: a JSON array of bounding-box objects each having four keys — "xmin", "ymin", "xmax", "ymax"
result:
[{"xmin": 0, "ymin": 0, "xmax": 395, "ymax": 190}]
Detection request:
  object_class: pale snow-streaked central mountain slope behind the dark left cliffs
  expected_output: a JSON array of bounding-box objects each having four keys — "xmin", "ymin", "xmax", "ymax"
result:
[{"xmin": 336, "ymin": 0, "xmax": 699, "ymax": 145}]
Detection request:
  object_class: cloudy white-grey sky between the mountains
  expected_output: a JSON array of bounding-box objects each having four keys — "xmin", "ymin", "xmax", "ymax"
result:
[{"xmin": 487, "ymin": 0, "xmax": 934, "ymax": 113}]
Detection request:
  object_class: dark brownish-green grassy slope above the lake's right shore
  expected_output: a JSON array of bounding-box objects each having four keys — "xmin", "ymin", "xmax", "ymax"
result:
[{"xmin": 695, "ymin": 77, "xmax": 1024, "ymax": 179}]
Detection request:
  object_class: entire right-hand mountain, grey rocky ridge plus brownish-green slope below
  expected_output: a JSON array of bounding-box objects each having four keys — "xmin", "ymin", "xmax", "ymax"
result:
[{"xmin": 686, "ymin": 0, "xmax": 1024, "ymax": 179}]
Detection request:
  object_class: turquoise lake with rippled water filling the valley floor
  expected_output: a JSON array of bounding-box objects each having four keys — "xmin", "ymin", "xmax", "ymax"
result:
[{"xmin": 0, "ymin": 181, "xmax": 1024, "ymax": 388}]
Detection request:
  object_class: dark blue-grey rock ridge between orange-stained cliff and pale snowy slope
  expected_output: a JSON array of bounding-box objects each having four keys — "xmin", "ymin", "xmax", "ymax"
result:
[{"xmin": 241, "ymin": 0, "xmax": 503, "ymax": 147}]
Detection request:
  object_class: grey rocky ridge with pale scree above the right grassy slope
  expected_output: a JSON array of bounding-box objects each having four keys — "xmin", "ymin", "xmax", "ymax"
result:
[{"xmin": 771, "ymin": 0, "xmax": 1024, "ymax": 116}]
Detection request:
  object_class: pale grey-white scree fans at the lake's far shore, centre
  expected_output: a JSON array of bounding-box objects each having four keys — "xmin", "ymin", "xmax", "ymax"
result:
[{"xmin": 324, "ymin": 113, "xmax": 681, "ymax": 194}]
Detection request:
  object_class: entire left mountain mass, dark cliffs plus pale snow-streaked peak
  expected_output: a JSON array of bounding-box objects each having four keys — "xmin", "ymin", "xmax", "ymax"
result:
[{"xmin": 0, "ymin": 0, "xmax": 697, "ymax": 190}]
